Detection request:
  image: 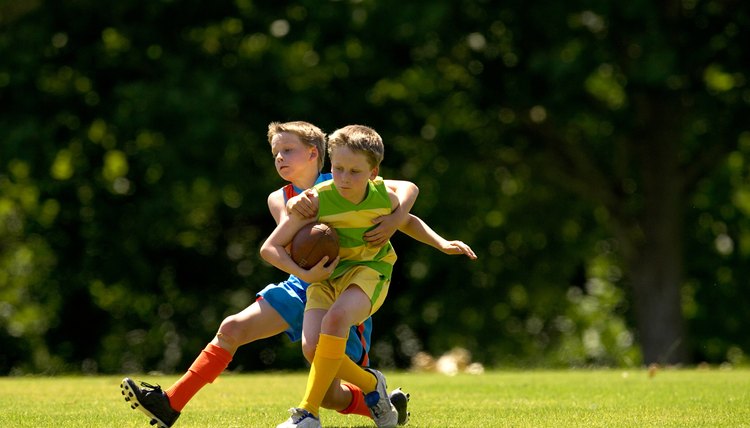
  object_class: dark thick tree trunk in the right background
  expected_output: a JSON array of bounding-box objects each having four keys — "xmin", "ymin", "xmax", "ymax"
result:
[{"xmin": 628, "ymin": 108, "xmax": 687, "ymax": 364}]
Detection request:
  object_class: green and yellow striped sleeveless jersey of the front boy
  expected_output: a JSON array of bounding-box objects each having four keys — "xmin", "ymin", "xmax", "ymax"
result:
[{"xmin": 315, "ymin": 177, "xmax": 396, "ymax": 279}]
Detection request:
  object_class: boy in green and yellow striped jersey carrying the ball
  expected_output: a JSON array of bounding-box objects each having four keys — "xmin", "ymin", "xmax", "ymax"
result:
[{"xmin": 261, "ymin": 125, "xmax": 428, "ymax": 428}]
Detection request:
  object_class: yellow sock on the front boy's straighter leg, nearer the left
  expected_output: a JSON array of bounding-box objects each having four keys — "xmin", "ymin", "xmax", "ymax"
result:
[{"xmin": 298, "ymin": 333, "xmax": 348, "ymax": 417}]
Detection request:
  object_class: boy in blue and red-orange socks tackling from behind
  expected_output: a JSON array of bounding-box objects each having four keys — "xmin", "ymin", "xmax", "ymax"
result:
[{"xmin": 121, "ymin": 122, "xmax": 476, "ymax": 427}]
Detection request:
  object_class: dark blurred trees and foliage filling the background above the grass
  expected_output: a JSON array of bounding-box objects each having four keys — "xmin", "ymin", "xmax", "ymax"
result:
[{"xmin": 0, "ymin": 0, "xmax": 750, "ymax": 374}]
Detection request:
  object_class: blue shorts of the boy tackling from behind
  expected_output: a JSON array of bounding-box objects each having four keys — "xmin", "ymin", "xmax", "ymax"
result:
[{"xmin": 256, "ymin": 275, "xmax": 372, "ymax": 367}]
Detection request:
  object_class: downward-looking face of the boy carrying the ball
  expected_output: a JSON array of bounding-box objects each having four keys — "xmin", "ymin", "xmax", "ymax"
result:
[{"xmin": 331, "ymin": 147, "xmax": 378, "ymax": 204}]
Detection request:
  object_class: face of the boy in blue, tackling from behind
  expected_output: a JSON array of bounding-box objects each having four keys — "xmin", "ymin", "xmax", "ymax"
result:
[{"xmin": 271, "ymin": 132, "xmax": 318, "ymax": 182}]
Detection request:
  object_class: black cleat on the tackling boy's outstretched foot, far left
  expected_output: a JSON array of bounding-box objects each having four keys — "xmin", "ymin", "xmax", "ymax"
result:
[{"xmin": 120, "ymin": 377, "xmax": 180, "ymax": 428}]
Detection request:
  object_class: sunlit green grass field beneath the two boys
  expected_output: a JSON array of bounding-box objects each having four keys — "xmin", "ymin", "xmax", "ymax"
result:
[{"xmin": 0, "ymin": 369, "xmax": 750, "ymax": 428}]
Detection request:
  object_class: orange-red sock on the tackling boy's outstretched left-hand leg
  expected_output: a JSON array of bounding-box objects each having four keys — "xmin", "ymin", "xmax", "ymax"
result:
[{"xmin": 164, "ymin": 343, "xmax": 232, "ymax": 412}]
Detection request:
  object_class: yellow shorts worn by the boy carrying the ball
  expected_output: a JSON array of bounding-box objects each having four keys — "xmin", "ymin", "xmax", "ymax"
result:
[{"xmin": 305, "ymin": 266, "xmax": 391, "ymax": 315}]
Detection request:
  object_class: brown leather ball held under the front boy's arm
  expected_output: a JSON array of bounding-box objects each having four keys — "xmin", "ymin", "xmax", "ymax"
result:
[{"xmin": 289, "ymin": 222, "xmax": 339, "ymax": 269}]
